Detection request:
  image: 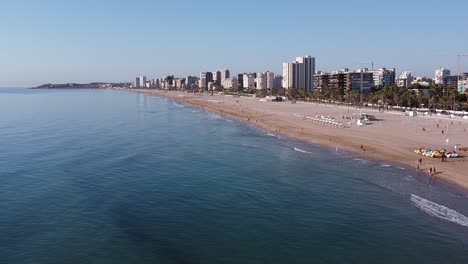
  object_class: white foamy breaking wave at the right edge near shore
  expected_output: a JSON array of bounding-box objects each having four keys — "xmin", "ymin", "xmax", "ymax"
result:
[{"xmin": 411, "ymin": 194, "xmax": 468, "ymax": 227}]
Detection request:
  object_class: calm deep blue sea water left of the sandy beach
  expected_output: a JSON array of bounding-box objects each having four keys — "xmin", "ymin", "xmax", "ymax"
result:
[{"xmin": 0, "ymin": 89, "xmax": 468, "ymax": 264}]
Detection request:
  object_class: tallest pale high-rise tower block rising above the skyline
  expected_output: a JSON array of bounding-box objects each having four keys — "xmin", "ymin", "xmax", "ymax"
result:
[{"xmin": 283, "ymin": 56, "xmax": 315, "ymax": 91}]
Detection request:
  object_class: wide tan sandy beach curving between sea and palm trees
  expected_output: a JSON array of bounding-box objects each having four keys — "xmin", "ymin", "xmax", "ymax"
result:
[{"xmin": 129, "ymin": 89, "xmax": 468, "ymax": 190}]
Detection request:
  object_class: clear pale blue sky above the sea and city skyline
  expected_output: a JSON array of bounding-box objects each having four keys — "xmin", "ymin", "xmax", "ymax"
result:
[{"xmin": 0, "ymin": 0, "xmax": 468, "ymax": 87}]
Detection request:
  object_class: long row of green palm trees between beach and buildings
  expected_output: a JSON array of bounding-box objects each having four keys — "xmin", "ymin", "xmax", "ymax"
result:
[{"xmin": 270, "ymin": 85, "xmax": 468, "ymax": 111}]
